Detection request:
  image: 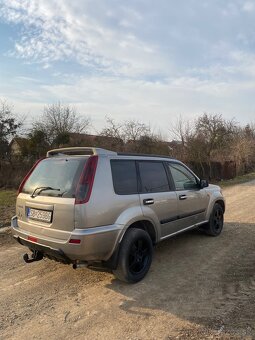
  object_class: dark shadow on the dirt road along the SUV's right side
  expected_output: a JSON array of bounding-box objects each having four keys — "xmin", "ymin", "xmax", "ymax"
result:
[{"xmin": 107, "ymin": 223, "xmax": 255, "ymax": 336}]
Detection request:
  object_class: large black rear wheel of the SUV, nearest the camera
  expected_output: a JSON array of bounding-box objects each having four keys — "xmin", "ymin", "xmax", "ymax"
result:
[{"xmin": 113, "ymin": 228, "xmax": 153, "ymax": 283}]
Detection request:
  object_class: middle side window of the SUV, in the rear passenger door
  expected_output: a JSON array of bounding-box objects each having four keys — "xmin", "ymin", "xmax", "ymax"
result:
[{"xmin": 138, "ymin": 161, "xmax": 170, "ymax": 193}]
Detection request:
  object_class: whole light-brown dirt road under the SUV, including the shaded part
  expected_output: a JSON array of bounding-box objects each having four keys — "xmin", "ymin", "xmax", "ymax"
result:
[{"xmin": 0, "ymin": 182, "xmax": 255, "ymax": 339}]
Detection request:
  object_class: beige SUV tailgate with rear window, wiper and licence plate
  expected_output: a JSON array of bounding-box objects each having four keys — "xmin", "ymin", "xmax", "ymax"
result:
[{"xmin": 16, "ymin": 157, "xmax": 87, "ymax": 240}]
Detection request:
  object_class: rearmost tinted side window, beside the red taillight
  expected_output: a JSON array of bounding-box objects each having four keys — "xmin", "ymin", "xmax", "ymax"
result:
[{"xmin": 111, "ymin": 160, "xmax": 138, "ymax": 195}]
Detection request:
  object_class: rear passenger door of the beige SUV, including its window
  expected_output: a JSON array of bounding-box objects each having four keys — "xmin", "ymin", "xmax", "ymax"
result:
[{"xmin": 137, "ymin": 160, "xmax": 178, "ymax": 238}]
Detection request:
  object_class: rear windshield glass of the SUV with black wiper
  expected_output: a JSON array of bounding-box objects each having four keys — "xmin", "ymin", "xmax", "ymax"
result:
[{"xmin": 22, "ymin": 157, "xmax": 87, "ymax": 198}]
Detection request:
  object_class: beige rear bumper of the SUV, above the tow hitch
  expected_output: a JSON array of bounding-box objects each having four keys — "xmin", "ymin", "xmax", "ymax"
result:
[{"xmin": 11, "ymin": 216, "xmax": 123, "ymax": 263}]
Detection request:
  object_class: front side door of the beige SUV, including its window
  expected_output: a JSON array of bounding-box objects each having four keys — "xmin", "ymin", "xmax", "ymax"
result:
[{"xmin": 167, "ymin": 162, "xmax": 209, "ymax": 230}]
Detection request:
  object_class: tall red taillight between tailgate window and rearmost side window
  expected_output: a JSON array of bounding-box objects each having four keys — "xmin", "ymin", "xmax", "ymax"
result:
[{"xmin": 75, "ymin": 156, "xmax": 98, "ymax": 204}]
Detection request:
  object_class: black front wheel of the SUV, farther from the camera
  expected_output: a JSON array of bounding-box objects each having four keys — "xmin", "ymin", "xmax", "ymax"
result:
[{"xmin": 202, "ymin": 203, "xmax": 224, "ymax": 236}]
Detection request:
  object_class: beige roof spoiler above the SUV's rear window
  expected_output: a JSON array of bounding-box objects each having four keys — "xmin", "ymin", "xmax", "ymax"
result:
[{"xmin": 46, "ymin": 146, "xmax": 117, "ymax": 157}]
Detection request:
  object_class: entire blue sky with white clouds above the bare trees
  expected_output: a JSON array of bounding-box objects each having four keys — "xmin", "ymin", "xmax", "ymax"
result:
[{"xmin": 0, "ymin": 0, "xmax": 255, "ymax": 134}]
